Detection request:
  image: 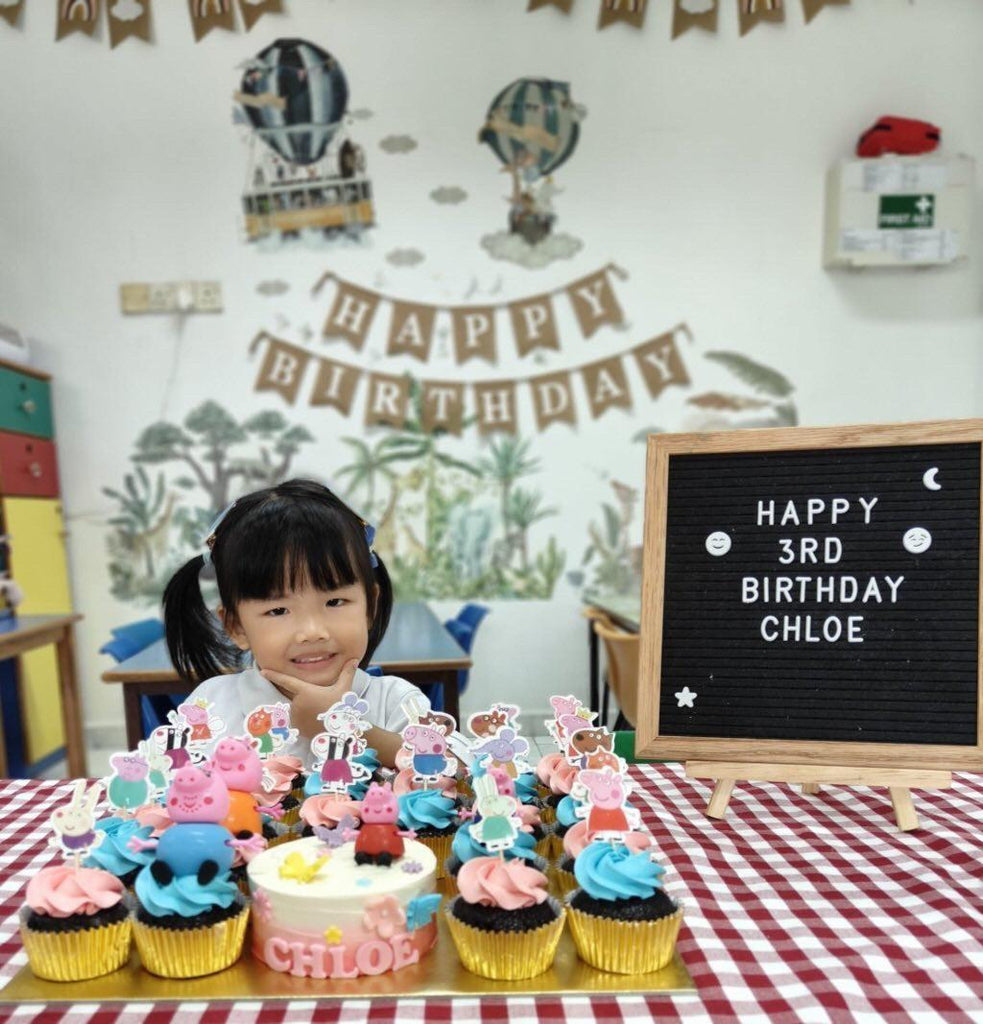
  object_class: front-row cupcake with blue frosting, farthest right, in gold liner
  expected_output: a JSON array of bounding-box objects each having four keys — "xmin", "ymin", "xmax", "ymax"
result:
[{"xmin": 567, "ymin": 842, "xmax": 683, "ymax": 974}]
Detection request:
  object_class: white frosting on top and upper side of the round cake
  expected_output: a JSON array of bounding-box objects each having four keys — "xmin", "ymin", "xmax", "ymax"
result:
[{"xmin": 247, "ymin": 837, "xmax": 437, "ymax": 933}]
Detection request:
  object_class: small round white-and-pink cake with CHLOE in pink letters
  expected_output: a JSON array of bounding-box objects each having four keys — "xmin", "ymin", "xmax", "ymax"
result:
[{"xmin": 248, "ymin": 837, "xmax": 439, "ymax": 978}]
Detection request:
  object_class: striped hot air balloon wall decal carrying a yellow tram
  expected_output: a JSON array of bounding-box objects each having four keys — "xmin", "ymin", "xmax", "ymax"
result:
[{"xmin": 234, "ymin": 39, "xmax": 375, "ymax": 241}]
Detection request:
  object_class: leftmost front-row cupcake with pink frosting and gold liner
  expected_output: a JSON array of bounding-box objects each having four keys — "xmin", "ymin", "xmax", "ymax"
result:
[{"xmin": 20, "ymin": 863, "xmax": 132, "ymax": 981}]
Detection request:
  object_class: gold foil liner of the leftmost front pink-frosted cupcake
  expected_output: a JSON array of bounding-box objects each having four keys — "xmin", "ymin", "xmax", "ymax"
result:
[{"xmin": 20, "ymin": 907, "xmax": 133, "ymax": 981}]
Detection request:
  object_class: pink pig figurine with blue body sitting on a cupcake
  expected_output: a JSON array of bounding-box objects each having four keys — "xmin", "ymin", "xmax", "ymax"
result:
[{"xmin": 129, "ymin": 765, "xmax": 261, "ymax": 886}]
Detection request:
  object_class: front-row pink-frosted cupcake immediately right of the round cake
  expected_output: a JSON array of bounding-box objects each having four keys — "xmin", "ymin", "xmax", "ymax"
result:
[{"xmin": 445, "ymin": 857, "xmax": 565, "ymax": 981}]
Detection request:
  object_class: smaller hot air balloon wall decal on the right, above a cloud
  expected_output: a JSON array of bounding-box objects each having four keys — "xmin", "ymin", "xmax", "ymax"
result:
[{"xmin": 478, "ymin": 78, "xmax": 582, "ymax": 245}]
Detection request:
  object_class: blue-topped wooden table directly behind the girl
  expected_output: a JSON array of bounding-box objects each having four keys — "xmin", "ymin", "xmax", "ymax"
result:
[{"xmin": 102, "ymin": 601, "xmax": 471, "ymax": 750}]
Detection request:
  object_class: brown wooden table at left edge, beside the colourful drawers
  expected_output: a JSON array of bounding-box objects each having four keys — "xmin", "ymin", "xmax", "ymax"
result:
[{"xmin": 0, "ymin": 614, "xmax": 88, "ymax": 778}]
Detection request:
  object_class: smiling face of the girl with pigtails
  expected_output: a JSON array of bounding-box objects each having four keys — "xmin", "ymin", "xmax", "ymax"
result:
[{"xmin": 219, "ymin": 583, "xmax": 369, "ymax": 686}]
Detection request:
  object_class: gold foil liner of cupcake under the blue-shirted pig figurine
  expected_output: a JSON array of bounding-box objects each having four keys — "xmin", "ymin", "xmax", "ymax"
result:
[{"xmin": 133, "ymin": 903, "xmax": 249, "ymax": 978}]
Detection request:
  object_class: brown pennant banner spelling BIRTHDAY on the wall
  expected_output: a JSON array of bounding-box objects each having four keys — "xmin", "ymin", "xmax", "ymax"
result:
[{"xmin": 250, "ymin": 324, "xmax": 690, "ymax": 435}]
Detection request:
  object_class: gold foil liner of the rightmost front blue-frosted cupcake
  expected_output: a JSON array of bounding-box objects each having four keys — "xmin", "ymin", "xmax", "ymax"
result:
[{"xmin": 566, "ymin": 896, "xmax": 683, "ymax": 974}]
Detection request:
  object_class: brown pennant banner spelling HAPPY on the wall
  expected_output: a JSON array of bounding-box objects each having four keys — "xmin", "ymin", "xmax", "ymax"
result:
[{"xmin": 313, "ymin": 264, "xmax": 628, "ymax": 366}]
